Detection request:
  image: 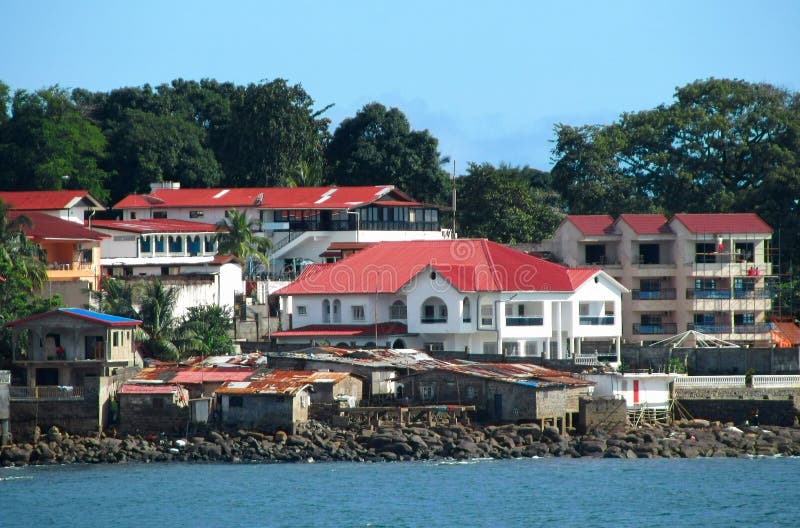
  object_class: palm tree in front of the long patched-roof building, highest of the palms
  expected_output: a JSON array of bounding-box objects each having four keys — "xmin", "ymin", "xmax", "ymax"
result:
[{"xmin": 217, "ymin": 209, "xmax": 272, "ymax": 275}]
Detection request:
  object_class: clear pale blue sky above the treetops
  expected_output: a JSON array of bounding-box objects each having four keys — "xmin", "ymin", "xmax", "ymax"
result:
[{"xmin": 0, "ymin": 0, "xmax": 800, "ymax": 174}]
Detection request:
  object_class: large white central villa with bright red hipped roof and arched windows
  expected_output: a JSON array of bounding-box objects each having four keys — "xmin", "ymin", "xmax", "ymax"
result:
[{"xmin": 272, "ymin": 239, "xmax": 627, "ymax": 359}]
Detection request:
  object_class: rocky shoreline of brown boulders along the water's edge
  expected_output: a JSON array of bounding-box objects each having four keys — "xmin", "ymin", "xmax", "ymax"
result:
[{"xmin": 0, "ymin": 420, "xmax": 800, "ymax": 467}]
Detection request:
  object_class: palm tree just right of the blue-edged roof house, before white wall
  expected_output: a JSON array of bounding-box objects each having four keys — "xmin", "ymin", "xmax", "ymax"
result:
[{"xmin": 139, "ymin": 279, "xmax": 179, "ymax": 361}]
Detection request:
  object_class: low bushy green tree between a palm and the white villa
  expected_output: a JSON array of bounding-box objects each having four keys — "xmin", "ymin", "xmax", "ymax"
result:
[{"xmin": 178, "ymin": 305, "xmax": 234, "ymax": 356}]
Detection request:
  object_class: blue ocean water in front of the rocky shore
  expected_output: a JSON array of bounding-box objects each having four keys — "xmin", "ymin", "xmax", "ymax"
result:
[{"xmin": 0, "ymin": 458, "xmax": 800, "ymax": 528}]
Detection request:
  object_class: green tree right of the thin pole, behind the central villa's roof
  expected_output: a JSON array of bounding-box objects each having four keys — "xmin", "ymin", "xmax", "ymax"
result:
[{"xmin": 456, "ymin": 163, "xmax": 561, "ymax": 243}]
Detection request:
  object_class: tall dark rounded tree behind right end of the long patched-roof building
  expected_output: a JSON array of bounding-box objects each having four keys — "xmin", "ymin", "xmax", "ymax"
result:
[{"xmin": 325, "ymin": 103, "xmax": 450, "ymax": 203}]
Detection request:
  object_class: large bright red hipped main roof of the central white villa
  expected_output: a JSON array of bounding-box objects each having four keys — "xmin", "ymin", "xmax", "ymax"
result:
[{"xmin": 276, "ymin": 239, "xmax": 597, "ymax": 295}]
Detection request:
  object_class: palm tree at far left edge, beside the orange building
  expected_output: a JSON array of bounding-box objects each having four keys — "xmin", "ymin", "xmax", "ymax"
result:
[{"xmin": 0, "ymin": 201, "xmax": 47, "ymax": 293}]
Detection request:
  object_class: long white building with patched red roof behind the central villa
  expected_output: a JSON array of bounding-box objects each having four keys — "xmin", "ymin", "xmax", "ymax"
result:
[{"xmin": 114, "ymin": 182, "xmax": 450, "ymax": 275}]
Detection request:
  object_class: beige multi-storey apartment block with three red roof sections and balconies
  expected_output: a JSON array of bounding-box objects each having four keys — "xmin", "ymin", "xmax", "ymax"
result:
[{"xmin": 542, "ymin": 213, "xmax": 776, "ymax": 345}]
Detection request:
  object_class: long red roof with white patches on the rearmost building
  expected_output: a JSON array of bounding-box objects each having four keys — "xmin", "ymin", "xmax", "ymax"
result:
[{"xmin": 114, "ymin": 185, "xmax": 417, "ymax": 209}]
